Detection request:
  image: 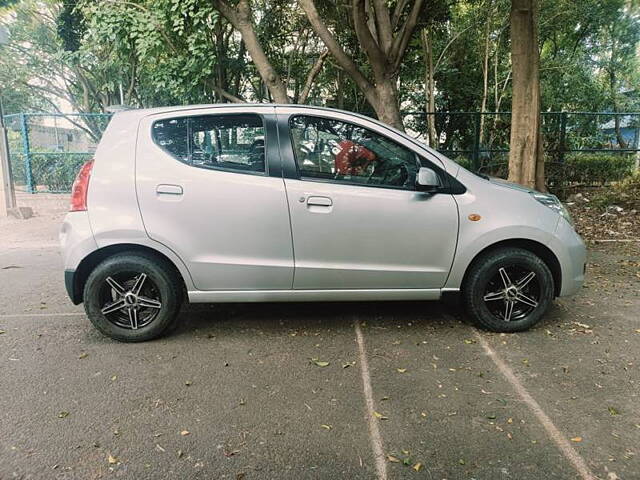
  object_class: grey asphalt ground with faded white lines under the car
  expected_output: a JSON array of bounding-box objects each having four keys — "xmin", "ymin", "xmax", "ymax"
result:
[{"xmin": 0, "ymin": 193, "xmax": 640, "ymax": 480}]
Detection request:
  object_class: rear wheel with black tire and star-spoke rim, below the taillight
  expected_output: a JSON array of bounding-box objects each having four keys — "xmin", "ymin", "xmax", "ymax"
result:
[{"xmin": 83, "ymin": 252, "xmax": 183, "ymax": 342}]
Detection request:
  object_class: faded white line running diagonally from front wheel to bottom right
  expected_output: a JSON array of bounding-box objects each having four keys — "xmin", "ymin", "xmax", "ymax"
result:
[{"xmin": 474, "ymin": 329, "xmax": 597, "ymax": 480}]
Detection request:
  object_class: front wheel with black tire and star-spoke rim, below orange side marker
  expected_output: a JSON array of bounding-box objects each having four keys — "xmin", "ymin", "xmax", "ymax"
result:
[{"xmin": 462, "ymin": 248, "xmax": 555, "ymax": 333}]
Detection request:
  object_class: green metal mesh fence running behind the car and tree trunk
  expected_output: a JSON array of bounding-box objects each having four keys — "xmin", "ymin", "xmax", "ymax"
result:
[{"xmin": 5, "ymin": 112, "xmax": 640, "ymax": 193}]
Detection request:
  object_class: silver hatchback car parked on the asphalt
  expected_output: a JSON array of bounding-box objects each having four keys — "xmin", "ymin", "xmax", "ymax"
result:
[{"xmin": 60, "ymin": 104, "xmax": 585, "ymax": 342}]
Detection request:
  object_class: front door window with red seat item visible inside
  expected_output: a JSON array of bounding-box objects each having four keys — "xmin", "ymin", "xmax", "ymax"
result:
[{"xmin": 290, "ymin": 116, "xmax": 420, "ymax": 189}]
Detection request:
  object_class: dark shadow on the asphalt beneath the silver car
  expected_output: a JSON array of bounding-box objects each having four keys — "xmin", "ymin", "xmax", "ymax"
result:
[{"xmin": 81, "ymin": 297, "xmax": 568, "ymax": 343}]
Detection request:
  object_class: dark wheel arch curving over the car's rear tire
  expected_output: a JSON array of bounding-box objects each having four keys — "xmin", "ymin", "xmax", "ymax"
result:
[{"xmin": 70, "ymin": 243, "xmax": 187, "ymax": 305}]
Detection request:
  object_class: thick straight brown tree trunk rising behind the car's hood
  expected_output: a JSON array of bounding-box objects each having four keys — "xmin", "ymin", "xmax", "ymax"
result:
[{"xmin": 509, "ymin": 0, "xmax": 545, "ymax": 190}]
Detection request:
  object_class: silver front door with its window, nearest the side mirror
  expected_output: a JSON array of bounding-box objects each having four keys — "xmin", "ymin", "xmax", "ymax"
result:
[{"xmin": 278, "ymin": 110, "xmax": 458, "ymax": 289}]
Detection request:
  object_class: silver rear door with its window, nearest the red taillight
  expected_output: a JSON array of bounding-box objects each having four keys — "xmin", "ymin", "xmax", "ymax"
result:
[{"xmin": 136, "ymin": 106, "xmax": 293, "ymax": 290}]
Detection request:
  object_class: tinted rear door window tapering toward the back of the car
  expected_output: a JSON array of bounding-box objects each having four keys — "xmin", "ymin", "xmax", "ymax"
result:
[{"xmin": 153, "ymin": 114, "xmax": 266, "ymax": 173}]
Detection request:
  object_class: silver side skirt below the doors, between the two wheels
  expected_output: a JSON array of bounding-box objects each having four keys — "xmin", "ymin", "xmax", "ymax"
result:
[{"xmin": 188, "ymin": 288, "xmax": 441, "ymax": 303}]
